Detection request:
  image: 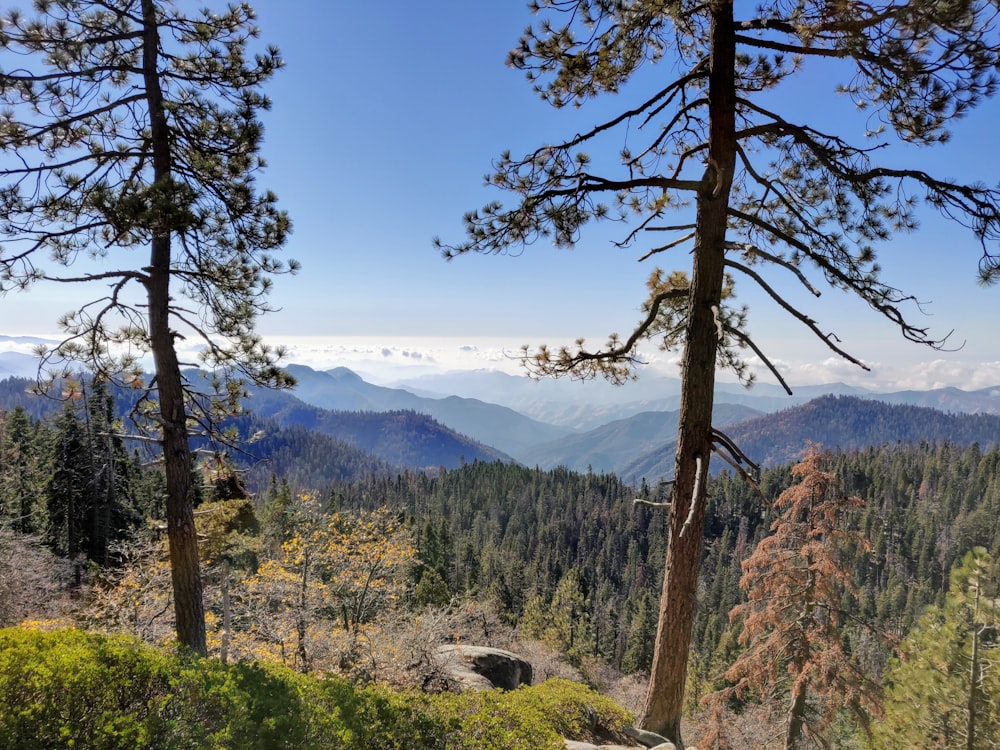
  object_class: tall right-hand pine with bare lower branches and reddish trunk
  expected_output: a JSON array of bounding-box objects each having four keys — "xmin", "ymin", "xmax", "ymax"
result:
[{"xmin": 438, "ymin": 0, "xmax": 1000, "ymax": 746}]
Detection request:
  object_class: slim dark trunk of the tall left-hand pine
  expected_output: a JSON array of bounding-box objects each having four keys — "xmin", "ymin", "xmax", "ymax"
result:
[{"xmin": 142, "ymin": 0, "xmax": 208, "ymax": 656}]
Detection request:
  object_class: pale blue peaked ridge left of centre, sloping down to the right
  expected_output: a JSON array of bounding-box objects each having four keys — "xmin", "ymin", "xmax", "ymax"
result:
[{"xmin": 288, "ymin": 365, "xmax": 572, "ymax": 460}]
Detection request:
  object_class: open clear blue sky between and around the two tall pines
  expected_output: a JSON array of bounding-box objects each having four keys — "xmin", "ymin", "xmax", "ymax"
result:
[{"xmin": 3, "ymin": 0, "xmax": 1000, "ymax": 388}]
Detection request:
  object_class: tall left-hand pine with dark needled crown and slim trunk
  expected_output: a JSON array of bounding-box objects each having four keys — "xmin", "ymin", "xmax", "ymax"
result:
[{"xmin": 0, "ymin": 0, "xmax": 289, "ymax": 654}]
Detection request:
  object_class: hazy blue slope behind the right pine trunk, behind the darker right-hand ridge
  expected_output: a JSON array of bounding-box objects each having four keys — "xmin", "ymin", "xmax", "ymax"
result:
[{"xmin": 532, "ymin": 404, "xmax": 760, "ymax": 473}]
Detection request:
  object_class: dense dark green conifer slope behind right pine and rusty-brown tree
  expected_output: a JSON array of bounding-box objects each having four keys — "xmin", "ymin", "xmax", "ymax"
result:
[{"xmin": 330, "ymin": 444, "xmax": 1000, "ymax": 720}]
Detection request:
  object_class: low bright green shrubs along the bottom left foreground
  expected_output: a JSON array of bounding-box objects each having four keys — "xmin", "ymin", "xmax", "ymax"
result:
[{"xmin": 0, "ymin": 629, "xmax": 630, "ymax": 750}]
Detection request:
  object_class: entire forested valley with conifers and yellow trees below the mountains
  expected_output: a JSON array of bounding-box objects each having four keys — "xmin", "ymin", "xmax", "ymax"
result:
[{"xmin": 0, "ymin": 378, "xmax": 1000, "ymax": 748}]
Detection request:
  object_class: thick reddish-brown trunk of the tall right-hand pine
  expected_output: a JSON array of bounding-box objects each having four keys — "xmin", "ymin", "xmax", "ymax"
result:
[{"xmin": 642, "ymin": 0, "xmax": 736, "ymax": 750}]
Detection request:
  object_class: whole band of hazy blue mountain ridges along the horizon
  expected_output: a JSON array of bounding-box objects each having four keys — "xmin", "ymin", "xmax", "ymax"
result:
[{"xmin": 0, "ymin": 352, "xmax": 1000, "ymax": 481}]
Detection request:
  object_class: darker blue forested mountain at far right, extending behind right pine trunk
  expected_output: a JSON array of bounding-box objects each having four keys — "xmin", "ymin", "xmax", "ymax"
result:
[{"xmin": 619, "ymin": 396, "xmax": 1000, "ymax": 481}]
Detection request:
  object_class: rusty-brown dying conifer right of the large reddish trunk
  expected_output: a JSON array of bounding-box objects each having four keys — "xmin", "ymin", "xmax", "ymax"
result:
[{"xmin": 708, "ymin": 448, "xmax": 880, "ymax": 750}]
